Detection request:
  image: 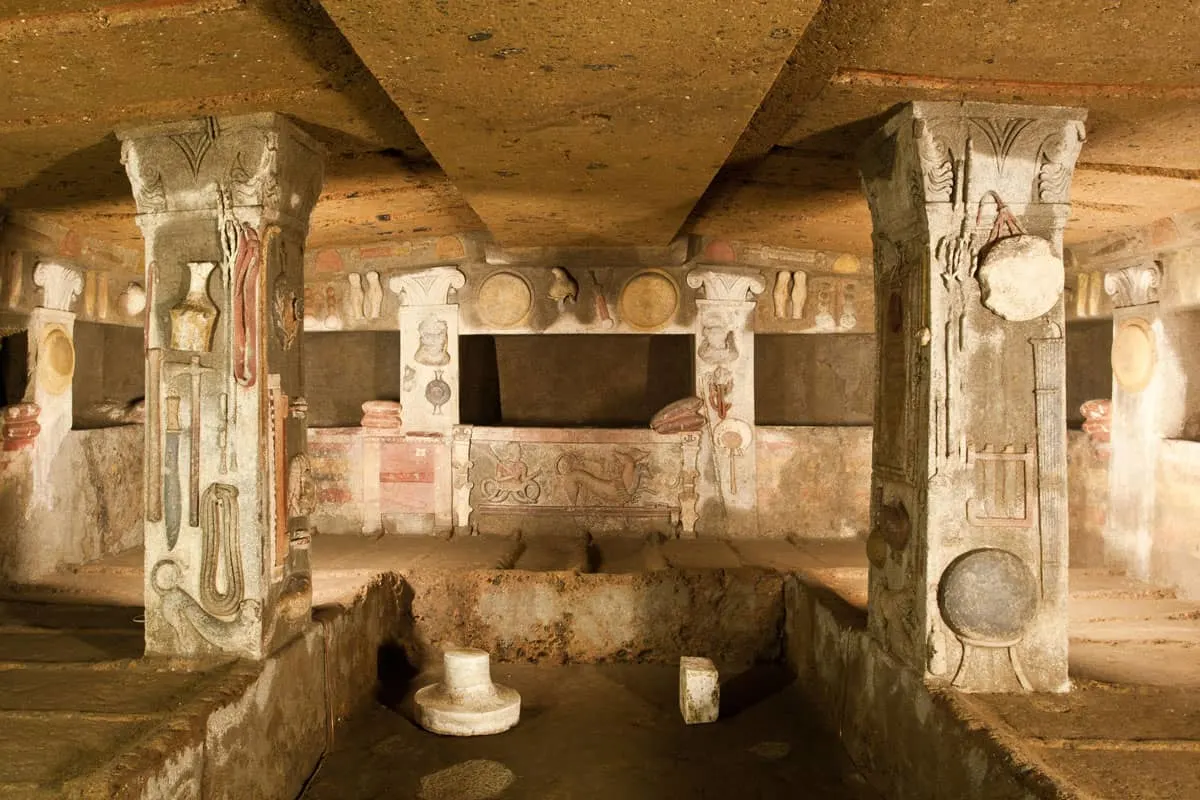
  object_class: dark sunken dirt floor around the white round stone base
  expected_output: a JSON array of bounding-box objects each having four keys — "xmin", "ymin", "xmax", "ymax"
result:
[{"xmin": 301, "ymin": 664, "xmax": 880, "ymax": 800}]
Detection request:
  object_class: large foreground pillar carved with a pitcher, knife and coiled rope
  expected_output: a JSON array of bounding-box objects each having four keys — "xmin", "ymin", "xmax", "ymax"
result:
[{"xmin": 120, "ymin": 114, "xmax": 324, "ymax": 658}]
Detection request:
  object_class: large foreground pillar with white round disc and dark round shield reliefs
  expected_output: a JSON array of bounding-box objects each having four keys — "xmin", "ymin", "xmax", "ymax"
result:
[{"xmin": 862, "ymin": 103, "xmax": 1085, "ymax": 692}]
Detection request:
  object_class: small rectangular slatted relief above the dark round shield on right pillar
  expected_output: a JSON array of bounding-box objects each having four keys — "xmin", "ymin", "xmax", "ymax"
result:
[{"xmin": 967, "ymin": 446, "xmax": 1037, "ymax": 528}]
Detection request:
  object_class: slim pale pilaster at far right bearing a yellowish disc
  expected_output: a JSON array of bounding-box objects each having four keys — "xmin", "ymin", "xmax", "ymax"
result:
[{"xmin": 1104, "ymin": 261, "xmax": 1161, "ymax": 579}]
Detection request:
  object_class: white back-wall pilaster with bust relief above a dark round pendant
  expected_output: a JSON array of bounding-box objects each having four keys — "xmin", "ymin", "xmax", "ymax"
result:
[{"xmin": 388, "ymin": 266, "xmax": 467, "ymax": 437}]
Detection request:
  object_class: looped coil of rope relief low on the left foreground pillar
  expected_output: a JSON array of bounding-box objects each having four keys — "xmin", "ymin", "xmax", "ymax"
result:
[{"xmin": 200, "ymin": 483, "xmax": 246, "ymax": 616}]
